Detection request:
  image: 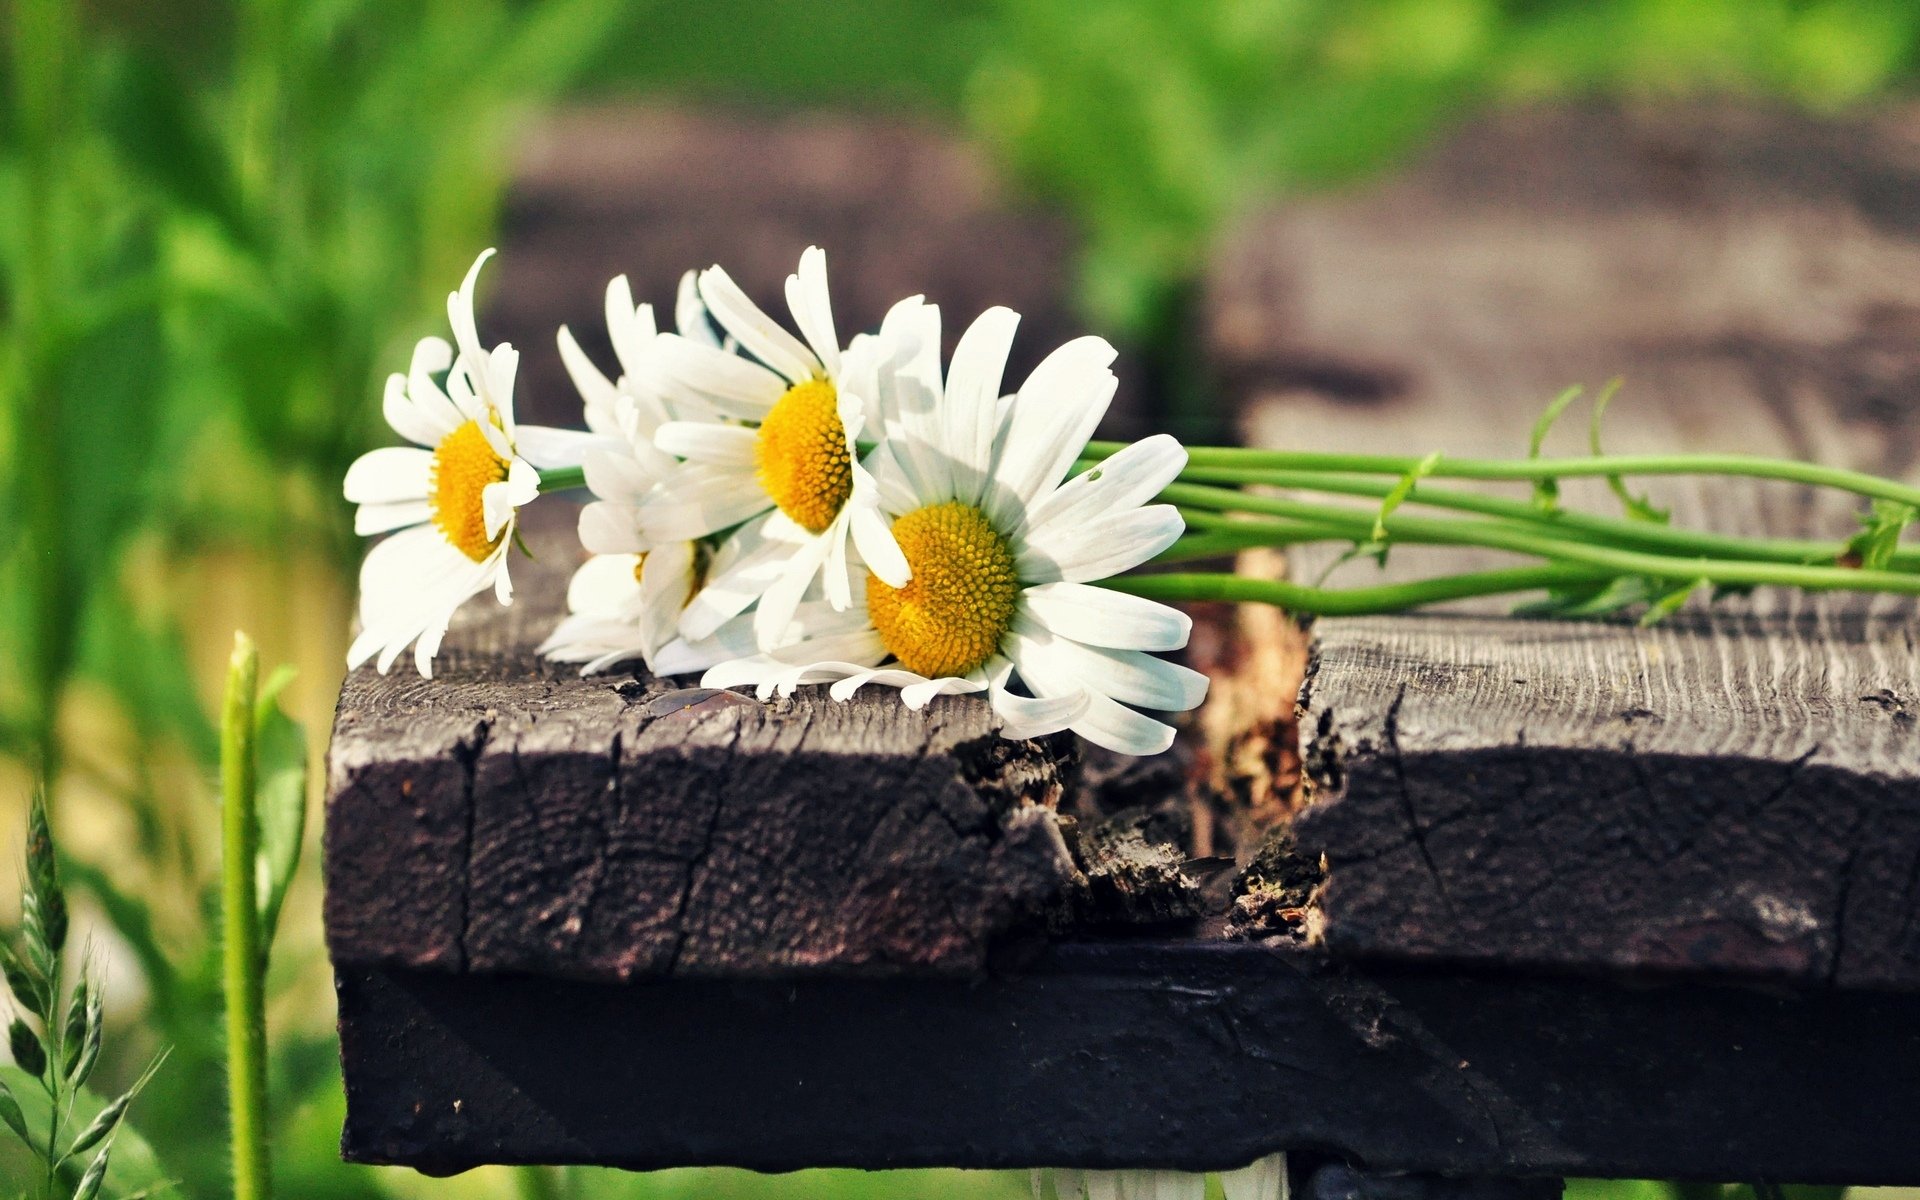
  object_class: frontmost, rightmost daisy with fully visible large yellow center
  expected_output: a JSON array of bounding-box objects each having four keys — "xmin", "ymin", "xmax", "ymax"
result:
[{"xmin": 703, "ymin": 300, "xmax": 1206, "ymax": 755}]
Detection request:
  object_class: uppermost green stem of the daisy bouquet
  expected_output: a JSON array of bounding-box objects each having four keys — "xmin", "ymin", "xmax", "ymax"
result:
[{"xmin": 1081, "ymin": 442, "xmax": 1920, "ymax": 509}]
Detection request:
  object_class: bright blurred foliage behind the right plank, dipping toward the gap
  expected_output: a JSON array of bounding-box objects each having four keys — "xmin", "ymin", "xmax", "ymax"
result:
[{"xmin": 966, "ymin": 0, "xmax": 1920, "ymax": 346}]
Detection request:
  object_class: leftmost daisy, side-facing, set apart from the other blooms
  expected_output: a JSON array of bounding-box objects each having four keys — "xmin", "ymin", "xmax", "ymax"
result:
[{"xmin": 342, "ymin": 250, "xmax": 593, "ymax": 676}]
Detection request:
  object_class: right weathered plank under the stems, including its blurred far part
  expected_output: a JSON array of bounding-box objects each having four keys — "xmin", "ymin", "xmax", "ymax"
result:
[{"xmin": 1215, "ymin": 109, "xmax": 1920, "ymax": 987}]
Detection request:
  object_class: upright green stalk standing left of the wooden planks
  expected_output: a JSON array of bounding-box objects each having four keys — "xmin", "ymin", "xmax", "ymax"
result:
[{"xmin": 221, "ymin": 634, "xmax": 273, "ymax": 1200}]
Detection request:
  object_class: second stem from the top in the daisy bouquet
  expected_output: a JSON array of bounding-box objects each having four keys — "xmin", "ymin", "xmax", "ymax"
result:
[{"xmin": 1181, "ymin": 467, "xmax": 1920, "ymax": 570}]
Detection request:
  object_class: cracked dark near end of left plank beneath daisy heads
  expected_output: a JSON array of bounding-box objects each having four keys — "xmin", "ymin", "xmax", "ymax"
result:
[{"xmin": 326, "ymin": 510, "xmax": 1073, "ymax": 979}]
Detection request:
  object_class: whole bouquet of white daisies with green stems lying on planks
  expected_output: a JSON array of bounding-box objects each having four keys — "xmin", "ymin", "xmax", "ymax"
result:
[{"xmin": 346, "ymin": 248, "xmax": 1920, "ymax": 755}]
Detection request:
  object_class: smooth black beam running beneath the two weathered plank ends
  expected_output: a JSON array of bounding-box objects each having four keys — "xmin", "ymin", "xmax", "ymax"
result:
[{"xmin": 340, "ymin": 939, "xmax": 1920, "ymax": 1185}]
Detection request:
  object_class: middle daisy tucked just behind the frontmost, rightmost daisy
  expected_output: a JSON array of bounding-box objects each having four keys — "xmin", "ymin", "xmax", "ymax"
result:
[{"xmin": 647, "ymin": 248, "xmax": 908, "ymax": 645}]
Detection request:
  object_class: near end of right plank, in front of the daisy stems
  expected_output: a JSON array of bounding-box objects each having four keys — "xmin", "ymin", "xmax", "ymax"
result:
[{"xmin": 1296, "ymin": 611, "xmax": 1920, "ymax": 989}]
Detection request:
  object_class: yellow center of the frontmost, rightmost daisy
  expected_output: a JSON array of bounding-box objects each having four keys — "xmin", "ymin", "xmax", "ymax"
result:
[{"xmin": 866, "ymin": 501, "xmax": 1020, "ymax": 680}]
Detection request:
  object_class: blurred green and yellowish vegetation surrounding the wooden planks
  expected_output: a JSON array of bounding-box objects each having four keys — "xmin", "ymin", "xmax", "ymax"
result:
[{"xmin": 0, "ymin": 0, "xmax": 1920, "ymax": 1200}]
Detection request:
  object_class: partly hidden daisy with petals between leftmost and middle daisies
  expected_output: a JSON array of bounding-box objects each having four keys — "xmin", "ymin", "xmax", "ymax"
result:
[{"xmin": 540, "ymin": 273, "xmax": 756, "ymax": 674}]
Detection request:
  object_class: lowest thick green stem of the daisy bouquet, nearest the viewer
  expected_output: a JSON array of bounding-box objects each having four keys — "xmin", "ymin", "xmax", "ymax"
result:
[{"xmin": 1100, "ymin": 564, "xmax": 1611, "ymax": 616}]
